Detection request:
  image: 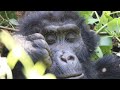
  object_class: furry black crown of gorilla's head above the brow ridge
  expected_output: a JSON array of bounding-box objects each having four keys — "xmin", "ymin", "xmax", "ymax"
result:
[{"xmin": 19, "ymin": 11, "xmax": 84, "ymax": 30}]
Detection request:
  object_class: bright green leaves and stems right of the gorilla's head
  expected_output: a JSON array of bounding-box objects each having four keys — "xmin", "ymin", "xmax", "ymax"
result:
[{"xmin": 80, "ymin": 11, "xmax": 120, "ymax": 60}]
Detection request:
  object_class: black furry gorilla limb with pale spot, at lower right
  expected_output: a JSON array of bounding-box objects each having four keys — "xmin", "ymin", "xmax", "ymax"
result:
[{"xmin": 95, "ymin": 55, "xmax": 120, "ymax": 79}]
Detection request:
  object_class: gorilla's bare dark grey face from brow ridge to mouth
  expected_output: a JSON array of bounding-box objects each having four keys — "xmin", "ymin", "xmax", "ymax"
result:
[{"xmin": 43, "ymin": 22, "xmax": 86, "ymax": 78}]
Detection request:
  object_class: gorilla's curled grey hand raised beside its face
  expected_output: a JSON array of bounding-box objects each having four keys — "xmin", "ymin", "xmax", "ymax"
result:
[{"xmin": 13, "ymin": 32, "xmax": 52, "ymax": 66}]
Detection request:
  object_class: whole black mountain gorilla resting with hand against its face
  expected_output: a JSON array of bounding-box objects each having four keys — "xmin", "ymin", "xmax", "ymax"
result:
[{"xmin": 3, "ymin": 11, "xmax": 120, "ymax": 79}]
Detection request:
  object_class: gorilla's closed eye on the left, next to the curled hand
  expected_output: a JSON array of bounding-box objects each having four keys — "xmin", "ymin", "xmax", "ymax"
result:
[{"xmin": 45, "ymin": 33, "xmax": 57, "ymax": 45}]
